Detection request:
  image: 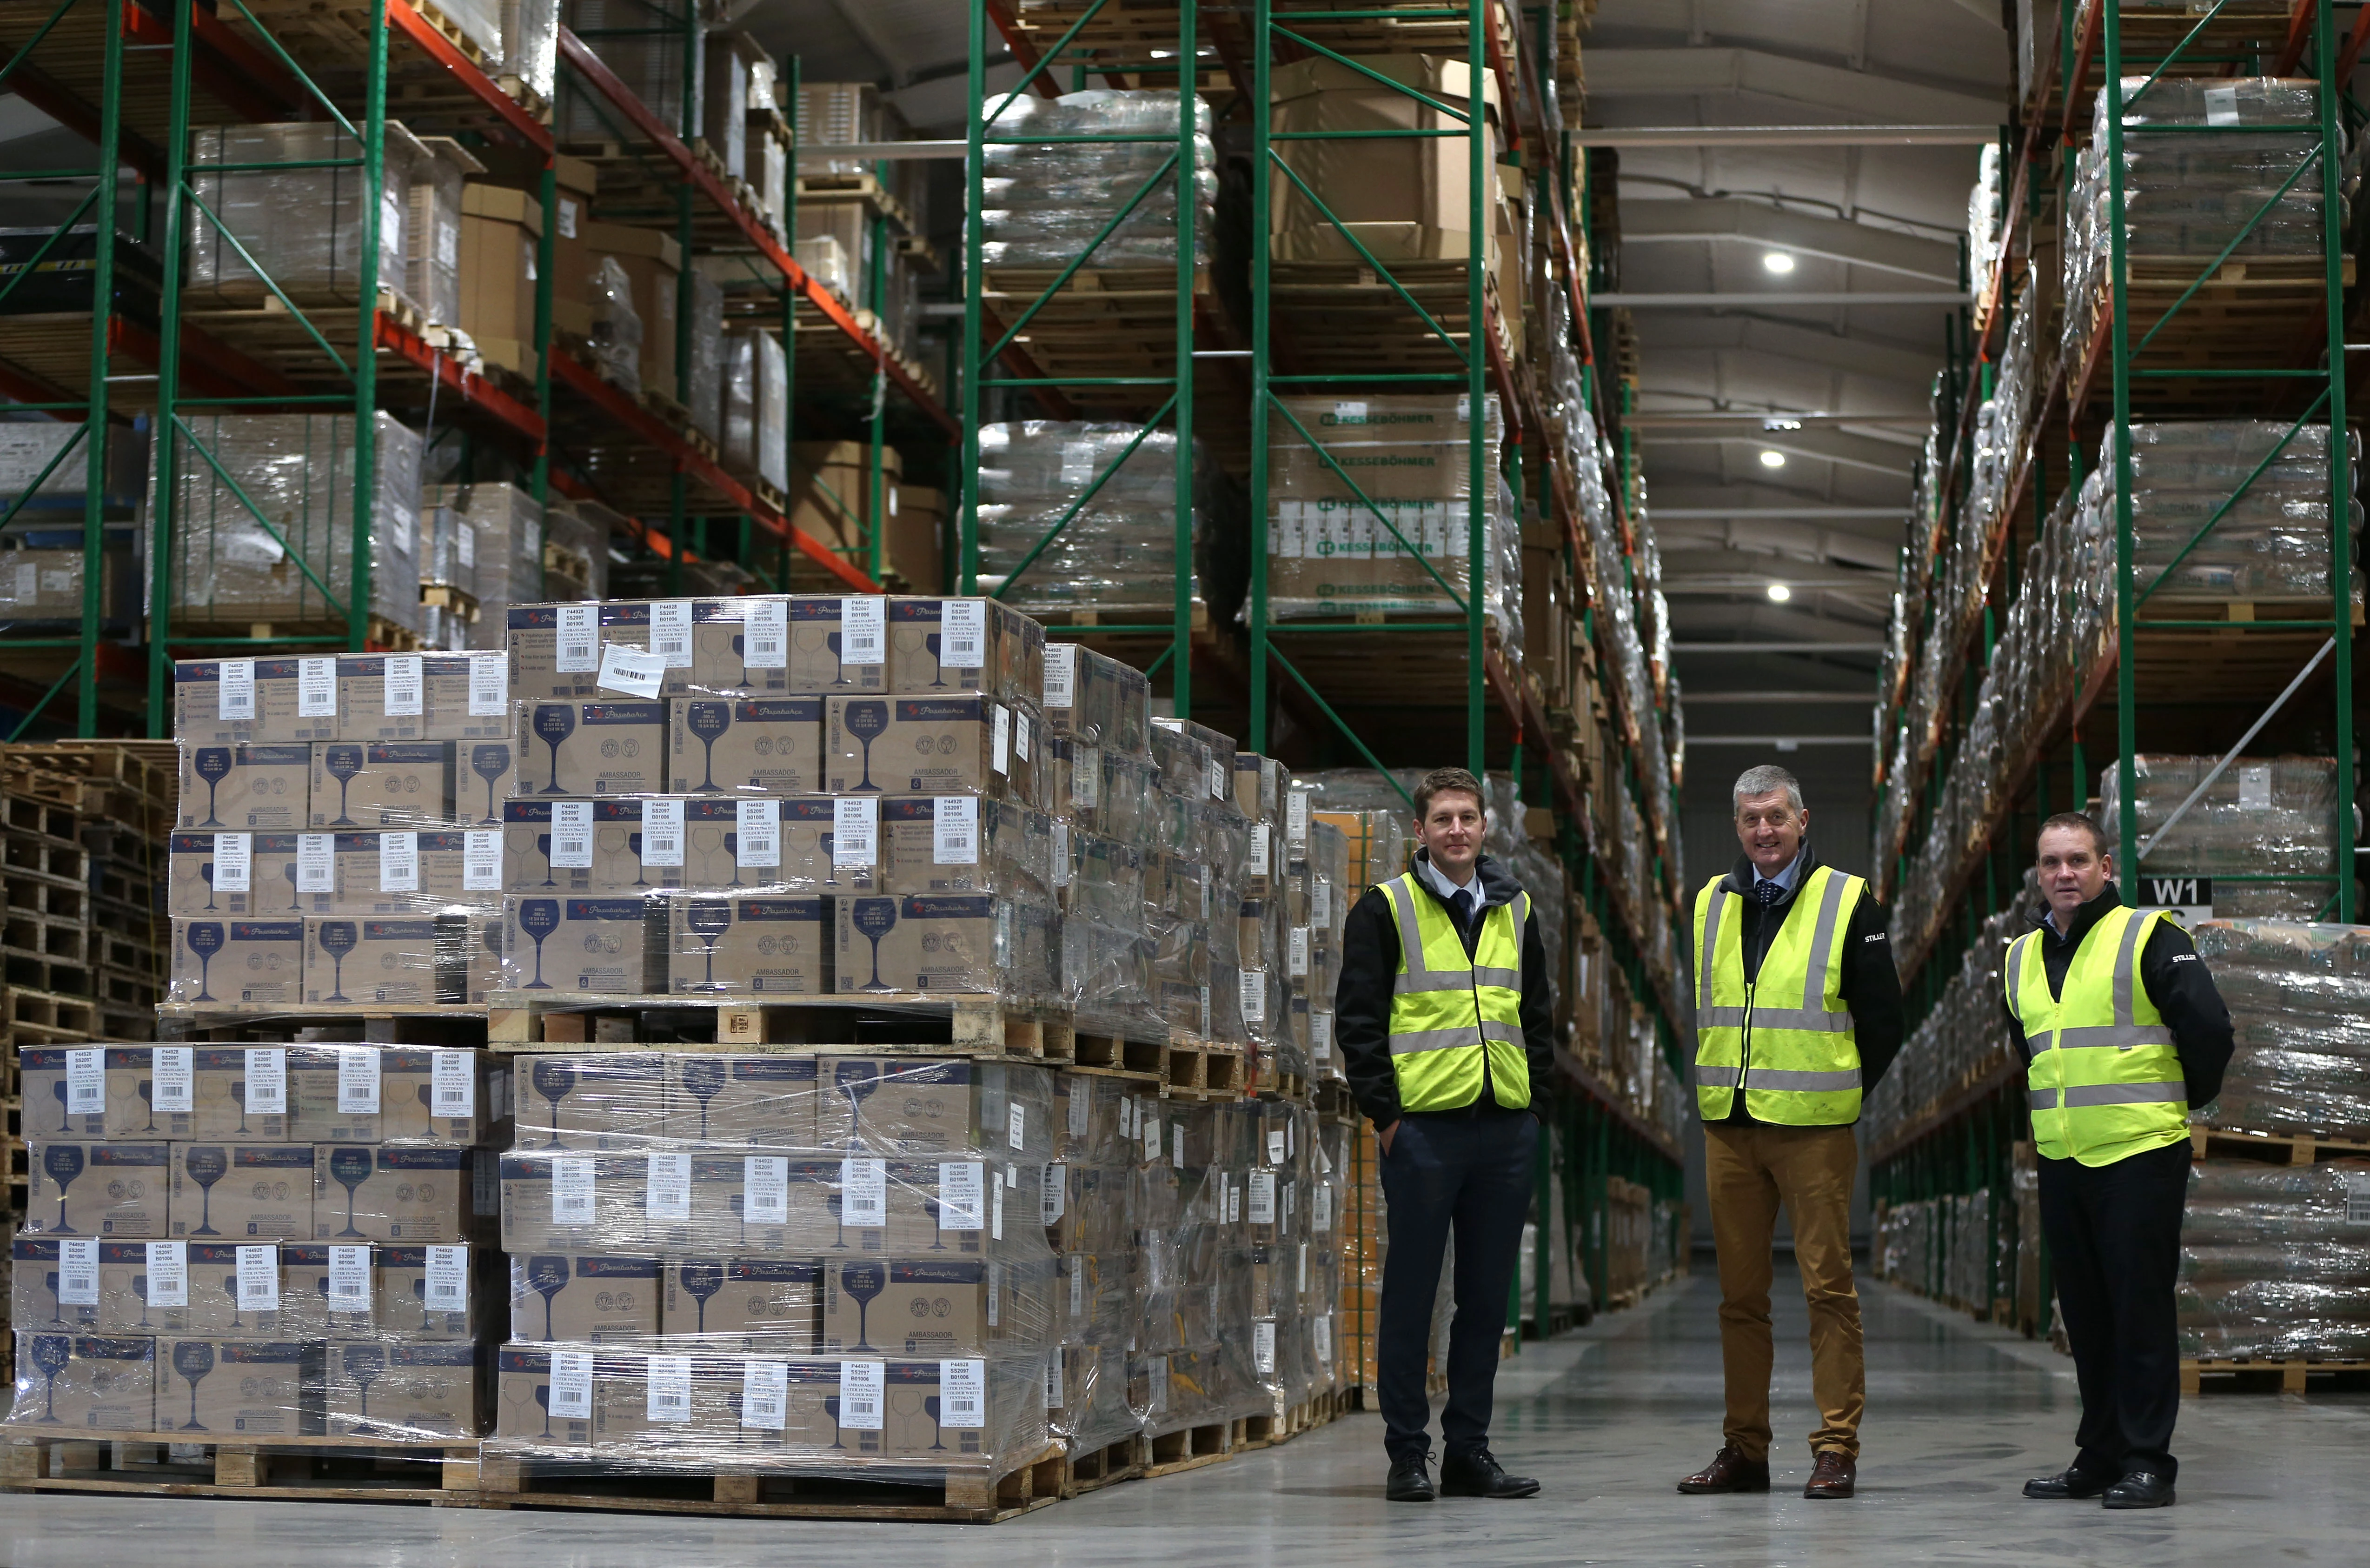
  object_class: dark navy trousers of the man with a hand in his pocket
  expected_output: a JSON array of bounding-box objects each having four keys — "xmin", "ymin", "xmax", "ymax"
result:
[{"xmin": 1374, "ymin": 1111, "xmax": 1538, "ymax": 1464}]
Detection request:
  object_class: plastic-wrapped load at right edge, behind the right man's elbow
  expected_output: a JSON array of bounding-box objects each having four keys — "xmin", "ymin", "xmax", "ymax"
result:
[{"xmin": 2195, "ymin": 924, "xmax": 2370, "ymax": 1139}]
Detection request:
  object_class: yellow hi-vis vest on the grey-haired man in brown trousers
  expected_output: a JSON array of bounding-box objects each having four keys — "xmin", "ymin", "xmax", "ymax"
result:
[{"xmin": 1694, "ymin": 867, "xmax": 1867, "ymax": 1128}]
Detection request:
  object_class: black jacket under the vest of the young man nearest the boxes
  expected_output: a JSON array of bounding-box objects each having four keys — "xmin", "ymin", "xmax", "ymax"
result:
[{"xmin": 1334, "ymin": 850, "xmax": 1555, "ymax": 1128}]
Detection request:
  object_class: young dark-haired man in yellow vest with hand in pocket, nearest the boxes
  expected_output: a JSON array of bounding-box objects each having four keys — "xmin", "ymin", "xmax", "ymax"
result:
[{"xmin": 1334, "ymin": 767, "xmax": 1555, "ymax": 1502}]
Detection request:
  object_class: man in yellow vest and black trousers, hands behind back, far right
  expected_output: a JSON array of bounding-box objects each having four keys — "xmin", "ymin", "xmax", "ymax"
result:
[{"xmin": 2000, "ymin": 812, "xmax": 2232, "ymax": 1509}]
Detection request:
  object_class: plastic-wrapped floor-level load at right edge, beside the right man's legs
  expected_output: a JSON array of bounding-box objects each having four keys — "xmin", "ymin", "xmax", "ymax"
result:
[{"xmin": 2176, "ymin": 1161, "xmax": 2370, "ymax": 1360}]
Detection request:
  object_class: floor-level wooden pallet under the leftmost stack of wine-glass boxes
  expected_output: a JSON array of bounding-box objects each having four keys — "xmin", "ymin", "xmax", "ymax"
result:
[{"xmin": 0, "ymin": 1426, "xmax": 479, "ymax": 1504}]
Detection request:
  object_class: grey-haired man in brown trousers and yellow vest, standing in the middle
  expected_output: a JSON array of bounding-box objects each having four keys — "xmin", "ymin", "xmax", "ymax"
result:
[{"xmin": 1678, "ymin": 767, "xmax": 1901, "ymax": 1497}]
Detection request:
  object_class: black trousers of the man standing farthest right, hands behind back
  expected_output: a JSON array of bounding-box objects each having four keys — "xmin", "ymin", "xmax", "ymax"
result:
[{"xmin": 2041, "ymin": 1139, "xmax": 2190, "ymax": 1481}]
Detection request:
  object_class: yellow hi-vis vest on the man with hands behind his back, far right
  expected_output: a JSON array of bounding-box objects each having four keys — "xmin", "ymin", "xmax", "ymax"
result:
[{"xmin": 2000, "ymin": 907, "xmax": 2190, "ymax": 1165}]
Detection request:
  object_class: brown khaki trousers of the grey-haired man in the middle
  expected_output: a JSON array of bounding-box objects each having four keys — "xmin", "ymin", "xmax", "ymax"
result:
[{"xmin": 1704, "ymin": 1123, "xmax": 1867, "ymax": 1462}]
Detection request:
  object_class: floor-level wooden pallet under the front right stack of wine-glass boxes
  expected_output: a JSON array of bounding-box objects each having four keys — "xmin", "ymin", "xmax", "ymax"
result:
[{"xmin": 469, "ymin": 1440, "xmax": 1062, "ymax": 1525}]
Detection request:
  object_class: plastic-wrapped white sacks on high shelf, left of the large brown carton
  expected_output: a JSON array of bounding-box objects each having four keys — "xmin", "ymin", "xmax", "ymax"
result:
[{"xmin": 979, "ymin": 87, "xmax": 1218, "ymax": 268}]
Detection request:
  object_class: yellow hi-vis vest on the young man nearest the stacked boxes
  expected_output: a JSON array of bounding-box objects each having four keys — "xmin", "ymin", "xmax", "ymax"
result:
[{"xmin": 1382, "ymin": 871, "xmax": 1531, "ymax": 1111}]
